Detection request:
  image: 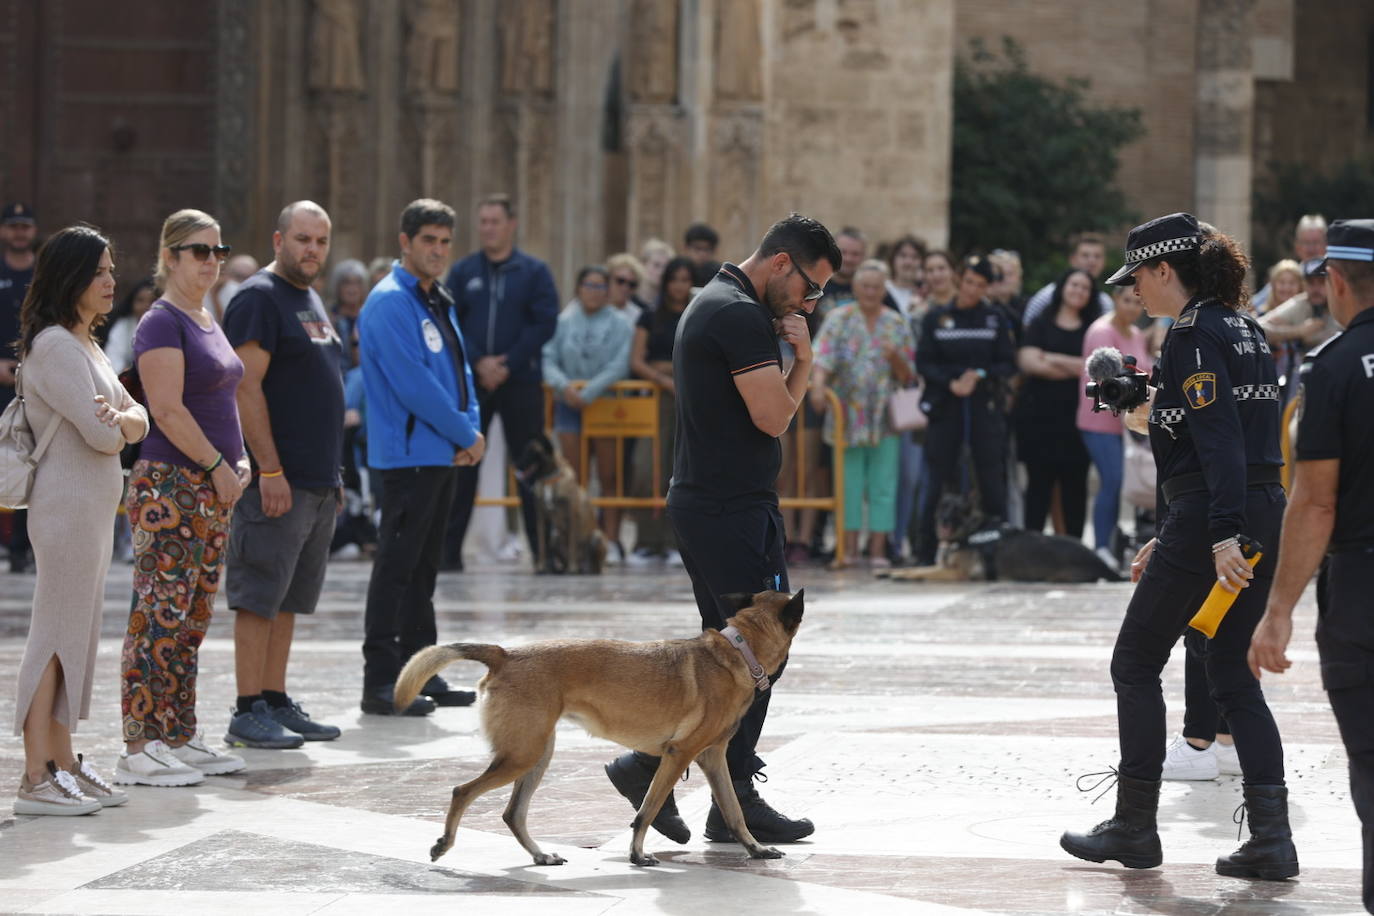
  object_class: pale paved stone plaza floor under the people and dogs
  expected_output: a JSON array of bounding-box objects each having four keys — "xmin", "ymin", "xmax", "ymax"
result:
[{"xmin": 0, "ymin": 554, "xmax": 1360, "ymax": 916}]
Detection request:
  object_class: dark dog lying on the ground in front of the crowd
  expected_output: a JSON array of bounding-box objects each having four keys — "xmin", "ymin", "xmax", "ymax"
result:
[{"xmin": 879, "ymin": 493, "xmax": 1123, "ymax": 582}]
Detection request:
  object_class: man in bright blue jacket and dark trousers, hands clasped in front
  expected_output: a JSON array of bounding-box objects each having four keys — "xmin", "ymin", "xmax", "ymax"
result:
[{"xmin": 359, "ymin": 199, "xmax": 486, "ymax": 715}]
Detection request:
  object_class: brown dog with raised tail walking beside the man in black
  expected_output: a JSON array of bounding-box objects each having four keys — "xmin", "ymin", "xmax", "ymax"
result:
[{"xmin": 396, "ymin": 592, "xmax": 804, "ymax": 865}]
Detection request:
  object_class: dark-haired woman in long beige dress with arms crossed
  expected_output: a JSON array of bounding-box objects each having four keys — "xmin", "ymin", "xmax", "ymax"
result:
[{"xmin": 14, "ymin": 227, "xmax": 148, "ymax": 814}]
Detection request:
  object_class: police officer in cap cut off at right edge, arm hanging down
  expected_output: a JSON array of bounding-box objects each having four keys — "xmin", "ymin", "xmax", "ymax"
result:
[{"xmin": 1250, "ymin": 220, "xmax": 1374, "ymax": 913}]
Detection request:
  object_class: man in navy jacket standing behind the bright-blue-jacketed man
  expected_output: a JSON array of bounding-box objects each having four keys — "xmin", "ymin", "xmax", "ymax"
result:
[{"xmin": 444, "ymin": 194, "xmax": 558, "ymax": 570}]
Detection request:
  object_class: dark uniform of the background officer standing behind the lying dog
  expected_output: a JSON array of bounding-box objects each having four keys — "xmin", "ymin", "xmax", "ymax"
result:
[{"xmin": 916, "ymin": 299, "xmax": 1017, "ymax": 564}]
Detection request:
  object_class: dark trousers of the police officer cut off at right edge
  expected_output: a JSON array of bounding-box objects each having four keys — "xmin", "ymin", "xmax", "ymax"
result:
[{"xmin": 1316, "ymin": 551, "xmax": 1374, "ymax": 913}]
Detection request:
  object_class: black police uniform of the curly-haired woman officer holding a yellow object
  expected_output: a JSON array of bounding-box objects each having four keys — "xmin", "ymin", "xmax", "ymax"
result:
[{"xmin": 1112, "ymin": 299, "xmax": 1285, "ymax": 786}]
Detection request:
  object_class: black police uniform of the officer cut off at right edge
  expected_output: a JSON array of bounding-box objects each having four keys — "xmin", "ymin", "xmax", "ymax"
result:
[{"xmin": 1297, "ymin": 306, "xmax": 1374, "ymax": 913}]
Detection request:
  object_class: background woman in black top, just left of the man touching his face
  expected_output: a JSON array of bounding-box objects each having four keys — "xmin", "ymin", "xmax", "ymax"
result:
[{"xmin": 629, "ymin": 257, "xmax": 692, "ymax": 563}]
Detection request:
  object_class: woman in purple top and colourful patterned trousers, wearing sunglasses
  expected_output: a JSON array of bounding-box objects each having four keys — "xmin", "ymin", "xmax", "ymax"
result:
[{"xmin": 114, "ymin": 210, "xmax": 249, "ymax": 786}]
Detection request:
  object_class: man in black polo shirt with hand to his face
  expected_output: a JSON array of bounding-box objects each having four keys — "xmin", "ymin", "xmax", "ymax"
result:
[{"xmin": 606, "ymin": 213, "xmax": 841, "ymax": 843}]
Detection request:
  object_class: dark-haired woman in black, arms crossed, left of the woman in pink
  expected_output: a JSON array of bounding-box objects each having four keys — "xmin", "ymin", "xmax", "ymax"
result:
[{"xmin": 1013, "ymin": 269, "xmax": 1102, "ymax": 537}]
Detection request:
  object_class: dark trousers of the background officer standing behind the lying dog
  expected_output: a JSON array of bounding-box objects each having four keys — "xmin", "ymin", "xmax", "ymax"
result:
[{"xmin": 921, "ymin": 398, "xmax": 1007, "ymax": 564}]
